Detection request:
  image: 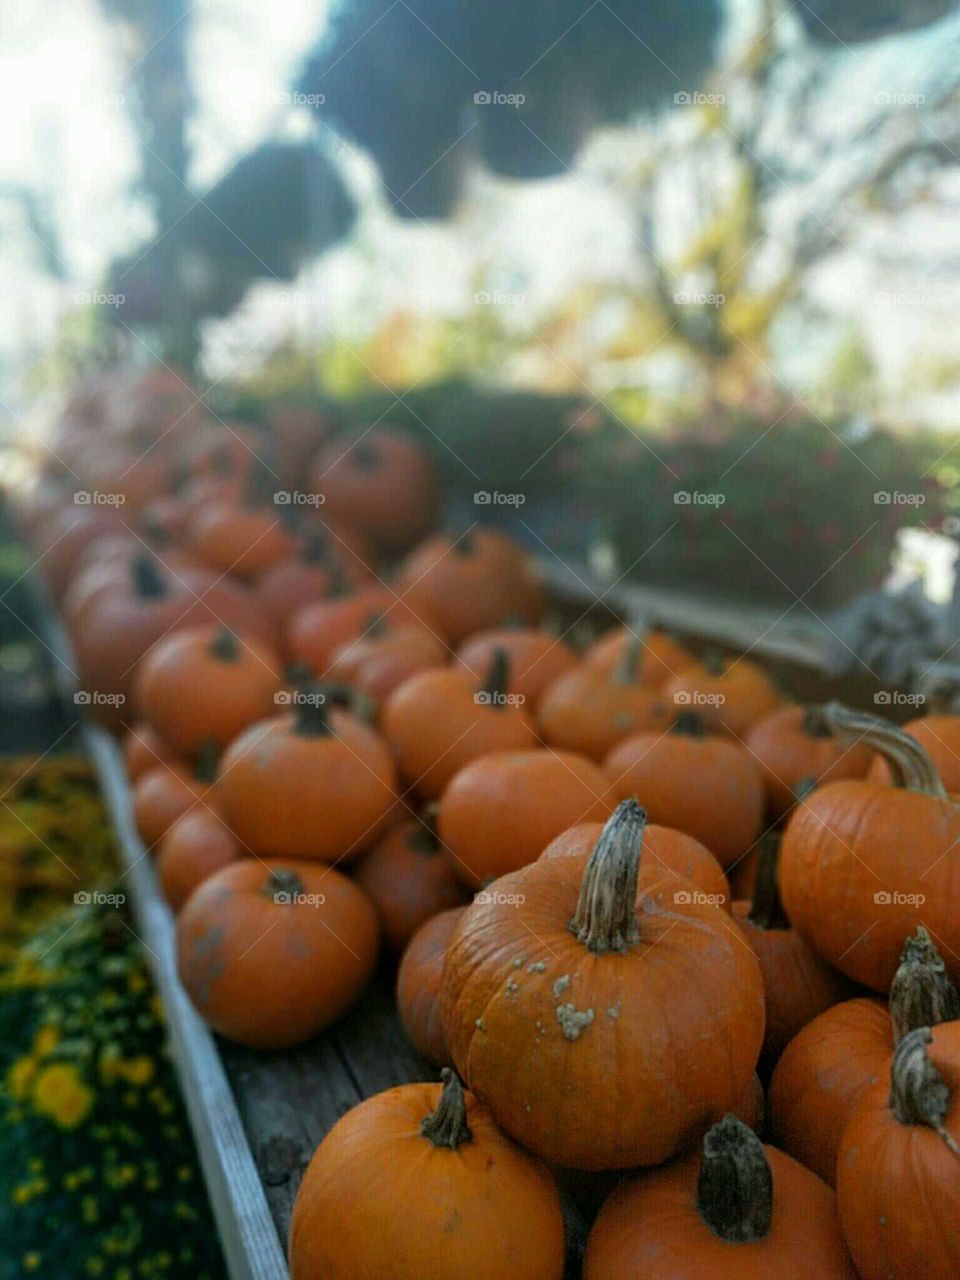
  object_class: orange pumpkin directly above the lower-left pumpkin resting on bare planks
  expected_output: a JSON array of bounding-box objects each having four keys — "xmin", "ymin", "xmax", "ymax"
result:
[{"xmin": 216, "ymin": 690, "xmax": 396, "ymax": 861}]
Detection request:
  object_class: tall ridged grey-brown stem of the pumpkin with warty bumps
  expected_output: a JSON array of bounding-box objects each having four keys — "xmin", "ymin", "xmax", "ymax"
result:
[{"xmin": 570, "ymin": 800, "xmax": 646, "ymax": 955}]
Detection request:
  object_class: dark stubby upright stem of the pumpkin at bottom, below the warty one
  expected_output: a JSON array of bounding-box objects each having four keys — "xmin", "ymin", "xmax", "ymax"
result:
[{"xmin": 696, "ymin": 1115, "xmax": 773, "ymax": 1244}]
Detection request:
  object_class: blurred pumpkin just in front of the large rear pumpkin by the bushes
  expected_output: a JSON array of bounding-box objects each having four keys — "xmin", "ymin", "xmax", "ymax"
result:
[{"xmin": 397, "ymin": 527, "xmax": 544, "ymax": 645}]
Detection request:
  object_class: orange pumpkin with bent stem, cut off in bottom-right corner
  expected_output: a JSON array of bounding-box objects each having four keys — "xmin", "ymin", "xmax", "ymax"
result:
[{"xmin": 837, "ymin": 1021, "xmax": 960, "ymax": 1280}]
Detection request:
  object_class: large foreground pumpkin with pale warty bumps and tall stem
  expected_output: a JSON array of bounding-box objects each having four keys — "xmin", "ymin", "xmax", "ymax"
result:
[{"xmin": 440, "ymin": 800, "xmax": 764, "ymax": 1170}]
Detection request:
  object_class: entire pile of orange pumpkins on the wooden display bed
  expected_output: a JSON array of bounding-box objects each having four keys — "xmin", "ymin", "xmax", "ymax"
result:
[{"xmin": 15, "ymin": 370, "xmax": 960, "ymax": 1280}]
